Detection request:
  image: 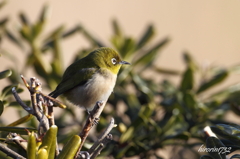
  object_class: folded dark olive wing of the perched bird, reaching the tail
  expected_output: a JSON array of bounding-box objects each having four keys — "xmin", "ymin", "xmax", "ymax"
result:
[{"xmin": 49, "ymin": 65, "xmax": 97, "ymax": 98}]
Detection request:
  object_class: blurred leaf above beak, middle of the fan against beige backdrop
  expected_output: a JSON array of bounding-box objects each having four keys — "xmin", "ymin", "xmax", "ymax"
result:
[{"xmin": 136, "ymin": 25, "xmax": 155, "ymax": 50}]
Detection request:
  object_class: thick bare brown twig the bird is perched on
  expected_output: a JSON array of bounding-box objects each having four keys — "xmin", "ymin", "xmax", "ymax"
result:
[{"xmin": 75, "ymin": 101, "xmax": 105, "ymax": 158}]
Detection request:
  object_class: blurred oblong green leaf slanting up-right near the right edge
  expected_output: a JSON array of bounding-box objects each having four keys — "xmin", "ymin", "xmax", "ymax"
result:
[{"xmin": 197, "ymin": 70, "xmax": 229, "ymax": 94}]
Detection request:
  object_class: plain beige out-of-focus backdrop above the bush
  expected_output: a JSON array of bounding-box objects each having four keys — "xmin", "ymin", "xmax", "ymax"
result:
[{"xmin": 1, "ymin": 0, "xmax": 240, "ymax": 74}]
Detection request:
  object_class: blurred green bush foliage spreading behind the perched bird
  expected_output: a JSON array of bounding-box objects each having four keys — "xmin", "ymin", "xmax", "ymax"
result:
[{"xmin": 0, "ymin": 2, "xmax": 240, "ymax": 158}]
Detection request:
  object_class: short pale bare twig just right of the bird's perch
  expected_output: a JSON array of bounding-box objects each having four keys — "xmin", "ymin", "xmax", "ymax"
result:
[{"xmin": 88, "ymin": 118, "xmax": 115, "ymax": 156}]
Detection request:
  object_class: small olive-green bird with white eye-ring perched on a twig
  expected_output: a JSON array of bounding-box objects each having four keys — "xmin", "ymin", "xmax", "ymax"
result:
[{"xmin": 49, "ymin": 47, "xmax": 130, "ymax": 111}]
